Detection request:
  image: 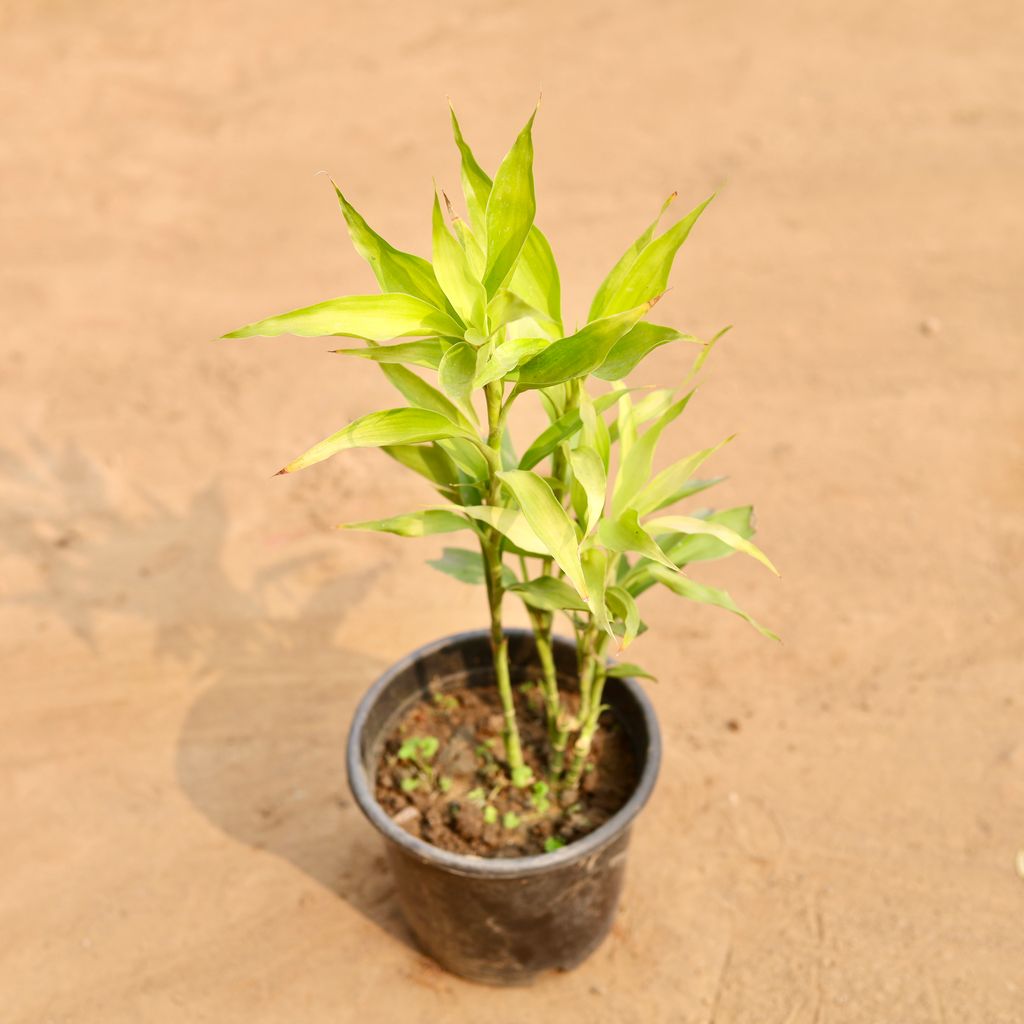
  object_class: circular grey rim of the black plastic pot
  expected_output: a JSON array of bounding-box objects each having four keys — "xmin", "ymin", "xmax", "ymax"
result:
[{"xmin": 346, "ymin": 629, "xmax": 662, "ymax": 879}]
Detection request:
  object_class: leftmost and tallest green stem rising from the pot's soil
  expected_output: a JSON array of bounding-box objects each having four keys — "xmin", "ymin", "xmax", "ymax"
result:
[{"xmin": 480, "ymin": 381, "xmax": 528, "ymax": 785}]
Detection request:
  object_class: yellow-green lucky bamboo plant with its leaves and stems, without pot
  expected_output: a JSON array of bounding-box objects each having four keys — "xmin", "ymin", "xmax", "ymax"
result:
[{"xmin": 224, "ymin": 111, "xmax": 777, "ymax": 792}]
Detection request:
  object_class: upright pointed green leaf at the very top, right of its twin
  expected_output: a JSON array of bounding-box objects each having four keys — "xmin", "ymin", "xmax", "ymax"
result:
[{"xmin": 483, "ymin": 111, "xmax": 537, "ymax": 297}]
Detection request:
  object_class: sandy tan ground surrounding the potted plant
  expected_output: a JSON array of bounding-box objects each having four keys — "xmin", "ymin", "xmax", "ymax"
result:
[{"xmin": 0, "ymin": 0, "xmax": 1024, "ymax": 1024}]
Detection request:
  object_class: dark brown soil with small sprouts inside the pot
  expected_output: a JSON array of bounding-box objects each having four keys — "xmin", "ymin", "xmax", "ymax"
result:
[{"xmin": 376, "ymin": 683, "xmax": 637, "ymax": 857}]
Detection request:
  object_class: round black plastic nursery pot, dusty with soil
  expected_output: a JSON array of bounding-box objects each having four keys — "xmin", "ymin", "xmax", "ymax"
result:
[{"xmin": 347, "ymin": 630, "xmax": 662, "ymax": 985}]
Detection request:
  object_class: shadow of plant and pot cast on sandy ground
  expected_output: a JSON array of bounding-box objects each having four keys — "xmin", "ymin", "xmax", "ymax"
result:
[{"xmin": 0, "ymin": 439, "xmax": 416, "ymax": 948}]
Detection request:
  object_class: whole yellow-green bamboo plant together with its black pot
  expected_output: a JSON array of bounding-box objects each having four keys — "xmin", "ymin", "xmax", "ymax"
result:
[{"xmin": 225, "ymin": 103, "xmax": 774, "ymax": 984}]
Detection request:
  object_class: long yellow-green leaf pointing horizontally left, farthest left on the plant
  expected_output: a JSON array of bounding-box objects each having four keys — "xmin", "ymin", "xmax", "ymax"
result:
[{"xmin": 224, "ymin": 292, "xmax": 462, "ymax": 341}]
